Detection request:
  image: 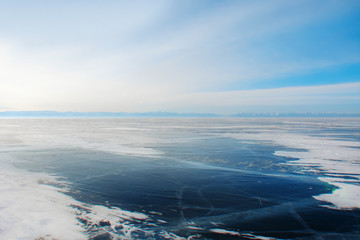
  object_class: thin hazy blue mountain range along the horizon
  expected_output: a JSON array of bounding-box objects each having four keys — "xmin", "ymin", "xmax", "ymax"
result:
[{"xmin": 0, "ymin": 111, "xmax": 360, "ymax": 118}]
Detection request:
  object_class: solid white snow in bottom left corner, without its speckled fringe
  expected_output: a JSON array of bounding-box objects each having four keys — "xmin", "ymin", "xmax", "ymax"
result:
[{"xmin": 0, "ymin": 164, "xmax": 87, "ymax": 240}]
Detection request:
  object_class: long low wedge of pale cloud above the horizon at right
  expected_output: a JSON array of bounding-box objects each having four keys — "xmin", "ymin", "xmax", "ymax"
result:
[{"xmin": 148, "ymin": 82, "xmax": 360, "ymax": 113}]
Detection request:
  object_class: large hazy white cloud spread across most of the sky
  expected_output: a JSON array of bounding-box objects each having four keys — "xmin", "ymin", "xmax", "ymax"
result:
[{"xmin": 0, "ymin": 1, "xmax": 359, "ymax": 111}]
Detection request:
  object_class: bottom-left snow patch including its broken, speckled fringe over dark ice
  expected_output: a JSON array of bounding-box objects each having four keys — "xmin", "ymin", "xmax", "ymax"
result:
[{"xmin": 0, "ymin": 159, "xmax": 169, "ymax": 240}]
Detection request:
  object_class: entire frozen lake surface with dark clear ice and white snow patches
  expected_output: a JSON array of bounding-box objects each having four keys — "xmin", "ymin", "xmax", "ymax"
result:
[{"xmin": 0, "ymin": 118, "xmax": 360, "ymax": 239}]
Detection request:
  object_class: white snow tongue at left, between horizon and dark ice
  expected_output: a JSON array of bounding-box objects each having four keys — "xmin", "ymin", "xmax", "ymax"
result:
[{"xmin": 0, "ymin": 119, "xmax": 161, "ymax": 157}]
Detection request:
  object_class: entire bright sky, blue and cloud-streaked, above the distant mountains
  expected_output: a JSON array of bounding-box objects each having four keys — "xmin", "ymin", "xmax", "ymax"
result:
[{"xmin": 0, "ymin": 0, "xmax": 360, "ymax": 114}]
